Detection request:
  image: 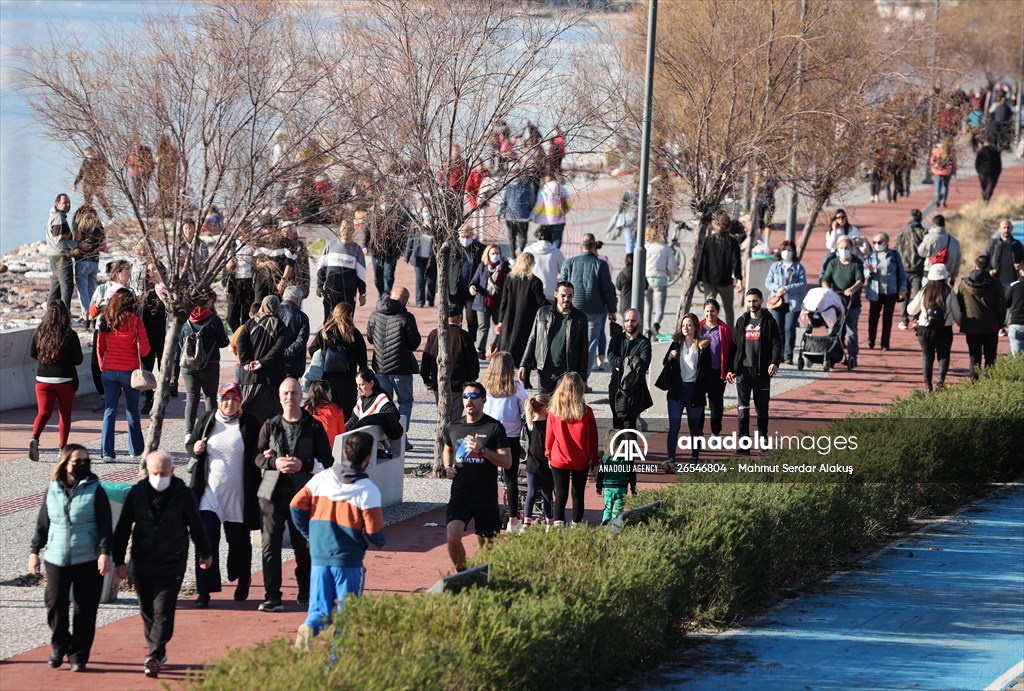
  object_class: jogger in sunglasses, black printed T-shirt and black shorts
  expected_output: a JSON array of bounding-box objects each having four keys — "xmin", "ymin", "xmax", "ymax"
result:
[{"xmin": 443, "ymin": 382, "xmax": 512, "ymax": 571}]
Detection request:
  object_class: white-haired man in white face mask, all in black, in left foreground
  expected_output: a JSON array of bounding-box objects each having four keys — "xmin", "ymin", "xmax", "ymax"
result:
[{"xmin": 114, "ymin": 451, "xmax": 213, "ymax": 678}]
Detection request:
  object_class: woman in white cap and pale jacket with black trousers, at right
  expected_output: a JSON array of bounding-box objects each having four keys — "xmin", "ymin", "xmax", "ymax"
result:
[{"xmin": 906, "ymin": 264, "xmax": 961, "ymax": 393}]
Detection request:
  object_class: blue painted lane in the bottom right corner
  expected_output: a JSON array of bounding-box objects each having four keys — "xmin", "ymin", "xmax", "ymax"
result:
[{"xmin": 643, "ymin": 484, "xmax": 1024, "ymax": 690}]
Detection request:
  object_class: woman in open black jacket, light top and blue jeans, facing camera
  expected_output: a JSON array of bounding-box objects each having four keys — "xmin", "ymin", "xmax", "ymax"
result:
[{"xmin": 654, "ymin": 313, "xmax": 715, "ymax": 472}]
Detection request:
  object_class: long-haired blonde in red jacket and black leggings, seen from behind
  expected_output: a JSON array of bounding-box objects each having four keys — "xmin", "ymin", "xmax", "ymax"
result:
[{"xmin": 544, "ymin": 372, "xmax": 601, "ymax": 527}]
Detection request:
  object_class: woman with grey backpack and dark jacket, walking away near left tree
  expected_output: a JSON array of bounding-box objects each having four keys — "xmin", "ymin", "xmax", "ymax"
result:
[{"xmin": 178, "ymin": 291, "xmax": 228, "ymax": 443}]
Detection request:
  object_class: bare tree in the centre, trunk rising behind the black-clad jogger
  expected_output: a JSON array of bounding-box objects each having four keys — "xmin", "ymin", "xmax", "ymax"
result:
[{"xmin": 317, "ymin": 0, "xmax": 591, "ymax": 475}]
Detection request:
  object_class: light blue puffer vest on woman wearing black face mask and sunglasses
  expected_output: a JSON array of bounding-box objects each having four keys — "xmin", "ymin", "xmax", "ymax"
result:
[{"xmin": 46, "ymin": 475, "xmax": 99, "ymax": 566}]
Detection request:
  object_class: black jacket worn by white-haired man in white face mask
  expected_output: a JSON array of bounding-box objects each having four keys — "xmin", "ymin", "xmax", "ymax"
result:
[{"xmin": 114, "ymin": 477, "xmax": 210, "ymax": 576}]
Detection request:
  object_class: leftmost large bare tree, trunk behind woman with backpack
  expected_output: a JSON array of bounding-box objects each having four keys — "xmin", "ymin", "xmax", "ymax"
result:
[{"xmin": 22, "ymin": 0, "xmax": 358, "ymax": 470}]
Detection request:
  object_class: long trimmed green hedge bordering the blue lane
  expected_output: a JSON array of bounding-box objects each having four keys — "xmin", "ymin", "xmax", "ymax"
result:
[{"xmin": 195, "ymin": 357, "xmax": 1024, "ymax": 689}]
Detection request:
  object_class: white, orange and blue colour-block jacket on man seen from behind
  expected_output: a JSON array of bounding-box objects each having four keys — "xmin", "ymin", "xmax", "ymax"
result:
[{"xmin": 291, "ymin": 471, "xmax": 385, "ymax": 568}]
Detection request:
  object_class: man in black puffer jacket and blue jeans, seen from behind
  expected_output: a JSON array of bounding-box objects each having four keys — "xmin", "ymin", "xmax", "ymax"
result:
[{"xmin": 367, "ymin": 286, "xmax": 421, "ymax": 450}]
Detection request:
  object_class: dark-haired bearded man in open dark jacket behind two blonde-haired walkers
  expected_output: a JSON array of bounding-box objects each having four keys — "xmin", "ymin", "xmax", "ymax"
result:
[{"xmin": 518, "ymin": 280, "xmax": 588, "ymax": 393}]
